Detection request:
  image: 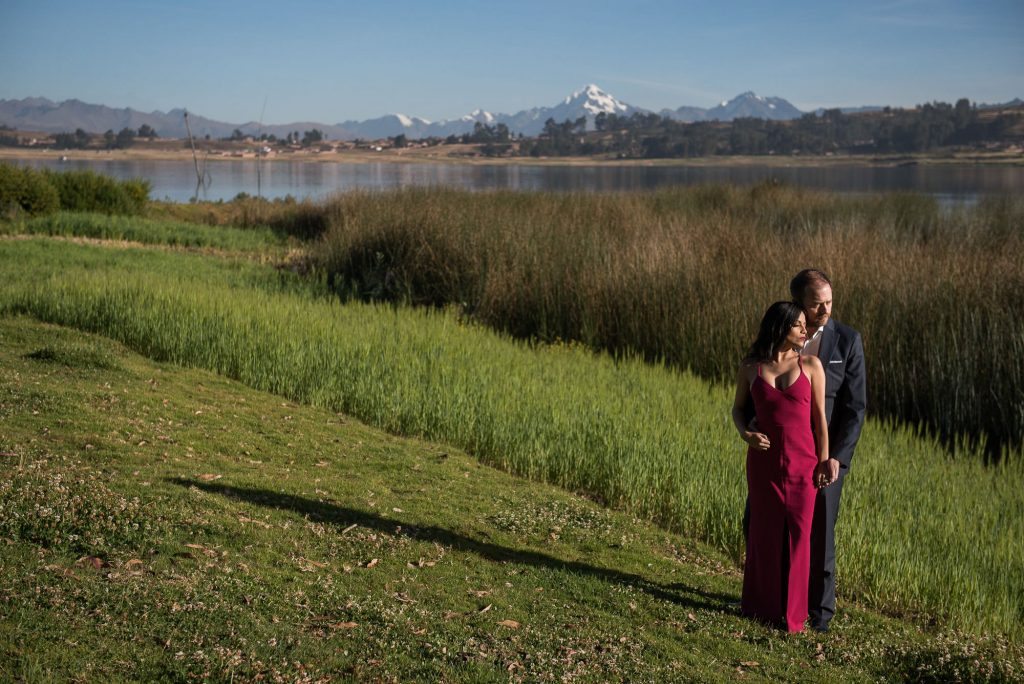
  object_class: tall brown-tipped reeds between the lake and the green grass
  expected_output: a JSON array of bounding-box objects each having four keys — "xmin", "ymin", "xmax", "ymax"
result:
[{"xmin": 306, "ymin": 183, "xmax": 1024, "ymax": 457}]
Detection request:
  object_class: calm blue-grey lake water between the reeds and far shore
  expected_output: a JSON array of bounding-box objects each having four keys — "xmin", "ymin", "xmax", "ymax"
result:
[{"xmin": 9, "ymin": 159, "xmax": 1024, "ymax": 204}]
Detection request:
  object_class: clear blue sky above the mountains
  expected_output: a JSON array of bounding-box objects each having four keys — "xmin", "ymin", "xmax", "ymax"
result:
[{"xmin": 0, "ymin": 0, "xmax": 1024, "ymax": 124}]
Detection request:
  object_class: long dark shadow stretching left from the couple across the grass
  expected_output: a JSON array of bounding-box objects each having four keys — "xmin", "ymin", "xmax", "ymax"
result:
[{"xmin": 174, "ymin": 477, "xmax": 737, "ymax": 611}]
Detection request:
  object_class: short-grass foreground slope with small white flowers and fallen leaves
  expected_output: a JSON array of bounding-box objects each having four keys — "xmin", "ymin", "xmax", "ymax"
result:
[{"xmin": 6, "ymin": 319, "xmax": 1024, "ymax": 681}]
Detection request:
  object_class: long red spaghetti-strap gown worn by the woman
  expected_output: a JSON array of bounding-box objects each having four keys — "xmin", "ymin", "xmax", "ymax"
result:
[{"xmin": 740, "ymin": 361, "xmax": 818, "ymax": 632}]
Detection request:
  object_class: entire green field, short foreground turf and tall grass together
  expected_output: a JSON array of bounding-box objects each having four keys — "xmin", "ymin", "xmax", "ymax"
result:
[{"xmin": 0, "ymin": 210, "xmax": 1024, "ymax": 681}]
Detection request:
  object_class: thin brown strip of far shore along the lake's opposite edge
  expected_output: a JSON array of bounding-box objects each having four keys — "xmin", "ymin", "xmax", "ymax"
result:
[{"xmin": 0, "ymin": 145, "xmax": 1024, "ymax": 168}]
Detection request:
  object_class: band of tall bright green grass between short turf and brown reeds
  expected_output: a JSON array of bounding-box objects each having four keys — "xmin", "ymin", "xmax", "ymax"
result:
[{"xmin": 0, "ymin": 240, "xmax": 1024, "ymax": 640}]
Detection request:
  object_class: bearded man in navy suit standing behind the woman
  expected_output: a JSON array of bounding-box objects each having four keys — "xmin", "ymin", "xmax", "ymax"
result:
[{"xmin": 790, "ymin": 268, "xmax": 866, "ymax": 632}]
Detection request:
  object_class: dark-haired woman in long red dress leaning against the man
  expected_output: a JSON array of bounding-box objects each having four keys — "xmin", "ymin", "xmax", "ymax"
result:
[{"xmin": 732, "ymin": 302, "xmax": 831, "ymax": 632}]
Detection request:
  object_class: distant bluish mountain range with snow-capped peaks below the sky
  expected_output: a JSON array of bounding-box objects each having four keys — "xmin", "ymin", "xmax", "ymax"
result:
[{"xmin": 0, "ymin": 85, "xmax": 1022, "ymax": 140}]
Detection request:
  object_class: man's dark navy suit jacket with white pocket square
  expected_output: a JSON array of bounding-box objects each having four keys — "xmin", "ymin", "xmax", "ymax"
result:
[{"xmin": 818, "ymin": 318, "xmax": 867, "ymax": 468}]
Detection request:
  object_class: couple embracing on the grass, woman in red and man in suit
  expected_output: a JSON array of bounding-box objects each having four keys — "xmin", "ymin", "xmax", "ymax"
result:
[{"xmin": 732, "ymin": 269, "xmax": 866, "ymax": 632}]
